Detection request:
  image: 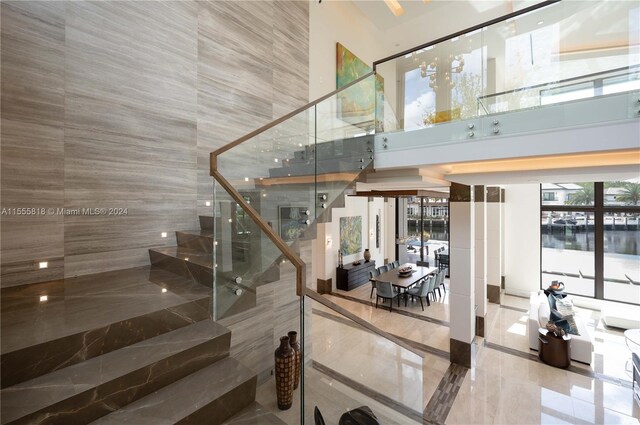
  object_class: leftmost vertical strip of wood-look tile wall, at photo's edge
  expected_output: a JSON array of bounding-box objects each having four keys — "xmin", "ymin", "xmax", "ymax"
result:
[{"xmin": 0, "ymin": 1, "xmax": 65, "ymax": 286}]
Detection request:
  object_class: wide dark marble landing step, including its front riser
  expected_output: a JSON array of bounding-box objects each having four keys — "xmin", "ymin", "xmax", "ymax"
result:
[{"xmin": 0, "ymin": 266, "xmax": 211, "ymax": 388}]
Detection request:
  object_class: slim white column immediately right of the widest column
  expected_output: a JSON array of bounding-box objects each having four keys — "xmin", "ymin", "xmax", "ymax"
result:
[{"xmin": 473, "ymin": 186, "xmax": 487, "ymax": 337}]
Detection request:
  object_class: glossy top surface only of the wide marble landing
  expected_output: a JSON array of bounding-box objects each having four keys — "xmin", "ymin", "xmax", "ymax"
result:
[{"xmin": 0, "ymin": 266, "xmax": 211, "ymax": 354}]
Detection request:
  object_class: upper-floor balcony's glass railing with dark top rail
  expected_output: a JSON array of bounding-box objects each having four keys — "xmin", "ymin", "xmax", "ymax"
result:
[{"xmin": 374, "ymin": 2, "xmax": 640, "ymax": 152}]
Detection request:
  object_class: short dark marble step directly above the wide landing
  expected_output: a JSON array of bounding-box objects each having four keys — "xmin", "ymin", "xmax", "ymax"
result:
[{"xmin": 149, "ymin": 246, "xmax": 213, "ymax": 288}]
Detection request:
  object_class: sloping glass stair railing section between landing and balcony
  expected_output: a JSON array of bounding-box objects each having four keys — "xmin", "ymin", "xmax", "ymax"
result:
[{"xmin": 211, "ymin": 74, "xmax": 375, "ymax": 318}]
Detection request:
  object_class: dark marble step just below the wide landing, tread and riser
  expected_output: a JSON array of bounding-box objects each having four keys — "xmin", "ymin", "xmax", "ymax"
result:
[{"xmin": 0, "ymin": 320, "xmax": 231, "ymax": 424}]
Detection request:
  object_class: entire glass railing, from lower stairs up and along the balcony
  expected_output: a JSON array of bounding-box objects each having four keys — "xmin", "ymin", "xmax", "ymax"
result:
[{"xmin": 211, "ymin": 0, "xmax": 640, "ymax": 423}]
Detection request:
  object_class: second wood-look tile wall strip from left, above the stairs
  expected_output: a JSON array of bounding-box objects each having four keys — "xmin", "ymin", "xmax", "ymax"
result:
[{"xmin": 65, "ymin": 2, "xmax": 197, "ymax": 276}]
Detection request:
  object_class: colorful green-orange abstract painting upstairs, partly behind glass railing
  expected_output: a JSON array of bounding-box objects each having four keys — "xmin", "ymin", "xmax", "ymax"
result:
[{"xmin": 336, "ymin": 43, "xmax": 384, "ymax": 131}]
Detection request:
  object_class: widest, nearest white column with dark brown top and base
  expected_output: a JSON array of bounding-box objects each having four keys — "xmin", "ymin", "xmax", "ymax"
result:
[{"xmin": 449, "ymin": 183, "xmax": 475, "ymax": 367}]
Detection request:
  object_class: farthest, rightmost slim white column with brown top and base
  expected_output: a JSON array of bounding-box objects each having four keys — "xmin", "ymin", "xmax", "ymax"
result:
[{"xmin": 486, "ymin": 187, "xmax": 502, "ymax": 304}]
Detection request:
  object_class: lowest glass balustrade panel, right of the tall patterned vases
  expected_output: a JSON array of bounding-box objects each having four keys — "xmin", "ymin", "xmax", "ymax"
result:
[{"xmin": 303, "ymin": 297, "xmax": 422, "ymax": 425}]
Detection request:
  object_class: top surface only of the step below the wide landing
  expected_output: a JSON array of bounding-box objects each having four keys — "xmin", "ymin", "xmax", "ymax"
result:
[{"xmin": 1, "ymin": 320, "xmax": 231, "ymax": 423}]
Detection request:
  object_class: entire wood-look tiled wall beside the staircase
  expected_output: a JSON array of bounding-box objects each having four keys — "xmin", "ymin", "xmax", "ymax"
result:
[{"xmin": 1, "ymin": 1, "xmax": 309, "ymax": 286}]
